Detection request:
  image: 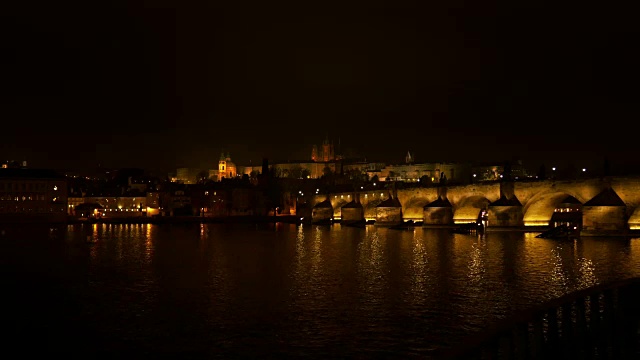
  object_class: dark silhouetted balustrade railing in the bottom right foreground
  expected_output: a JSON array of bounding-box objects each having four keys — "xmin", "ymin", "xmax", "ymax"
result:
[{"xmin": 439, "ymin": 278, "xmax": 640, "ymax": 360}]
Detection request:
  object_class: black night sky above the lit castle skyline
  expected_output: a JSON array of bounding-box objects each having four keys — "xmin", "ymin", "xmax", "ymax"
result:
[{"xmin": 0, "ymin": 0, "xmax": 640, "ymax": 173}]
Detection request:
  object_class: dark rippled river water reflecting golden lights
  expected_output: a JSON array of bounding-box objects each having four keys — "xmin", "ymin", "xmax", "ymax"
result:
[{"xmin": 0, "ymin": 224, "xmax": 640, "ymax": 358}]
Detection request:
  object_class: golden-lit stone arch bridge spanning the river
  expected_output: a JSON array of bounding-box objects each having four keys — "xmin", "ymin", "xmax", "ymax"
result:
[{"xmin": 302, "ymin": 177, "xmax": 640, "ymax": 230}]
